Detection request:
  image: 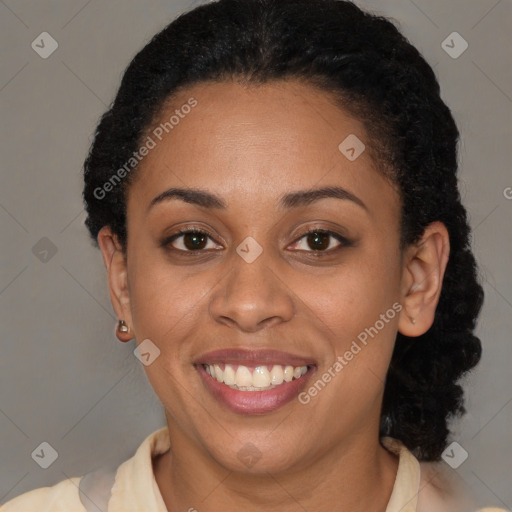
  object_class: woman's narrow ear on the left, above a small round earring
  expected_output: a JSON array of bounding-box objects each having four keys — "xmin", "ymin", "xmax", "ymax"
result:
[{"xmin": 98, "ymin": 226, "xmax": 133, "ymax": 341}]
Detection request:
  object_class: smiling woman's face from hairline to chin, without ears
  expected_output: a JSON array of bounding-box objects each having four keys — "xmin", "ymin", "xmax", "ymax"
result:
[{"xmin": 114, "ymin": 82, "xmax": 410, "ymax": 472}]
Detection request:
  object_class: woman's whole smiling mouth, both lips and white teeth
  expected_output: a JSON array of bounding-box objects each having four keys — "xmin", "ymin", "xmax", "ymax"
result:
[{"xmin": 194, "ymin": 349, "xmax": 316, "ymax": 414}]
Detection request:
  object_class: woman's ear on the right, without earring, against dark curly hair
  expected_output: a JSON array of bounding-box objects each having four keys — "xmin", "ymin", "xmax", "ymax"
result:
[{"xmin": 398, "ymin": 222, "xmax": 450, "ymax": 337}]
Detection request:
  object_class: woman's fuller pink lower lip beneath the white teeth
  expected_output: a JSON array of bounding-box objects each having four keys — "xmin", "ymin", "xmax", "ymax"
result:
[{"xmin": 196, "ymin": 364, "xmax": 313, "ymax": 414}]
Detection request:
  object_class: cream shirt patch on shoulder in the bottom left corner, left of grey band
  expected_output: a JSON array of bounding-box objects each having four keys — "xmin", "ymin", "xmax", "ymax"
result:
[{"xmin": 0, "ymin": 477, "xmax": 86, "ymax": 512}]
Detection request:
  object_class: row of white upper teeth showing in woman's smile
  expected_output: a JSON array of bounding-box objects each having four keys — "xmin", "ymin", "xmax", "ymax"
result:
[{"xmin": 204, "ymin": 364, "xmax": 308, "ymax": 391}]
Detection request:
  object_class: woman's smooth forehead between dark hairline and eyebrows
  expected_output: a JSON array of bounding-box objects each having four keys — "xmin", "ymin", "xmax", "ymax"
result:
[{"xmin": 128, "ymin": 81, "xmax": 396, "ymax": 218}]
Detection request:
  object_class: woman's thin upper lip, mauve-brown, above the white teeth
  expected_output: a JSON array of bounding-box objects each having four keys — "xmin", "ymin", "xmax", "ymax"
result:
[{"xmin": 194, "ymin": 348, "xmax": 316, "ymax": 366}]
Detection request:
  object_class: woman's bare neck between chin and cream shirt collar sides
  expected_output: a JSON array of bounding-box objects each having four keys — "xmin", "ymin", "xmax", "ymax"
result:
[{"xmin": 153, "ymin": 424, "xmax": 398, "ymax": 512}]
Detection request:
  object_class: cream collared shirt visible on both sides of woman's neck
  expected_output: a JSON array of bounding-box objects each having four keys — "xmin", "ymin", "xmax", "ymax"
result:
[{"xmin": 0, "ymin": 427, "xmax": 506, "ymax": 512}]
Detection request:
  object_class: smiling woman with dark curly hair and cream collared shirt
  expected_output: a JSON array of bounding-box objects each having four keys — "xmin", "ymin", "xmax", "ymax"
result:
[{"xmin": 2, "ymin": 0, "xmax": 506, "ymax": 512}]
